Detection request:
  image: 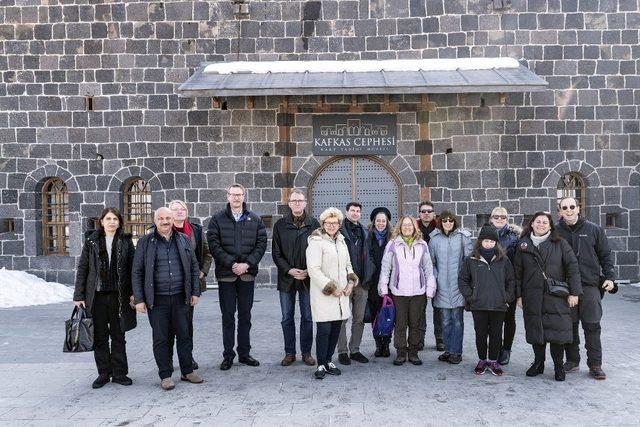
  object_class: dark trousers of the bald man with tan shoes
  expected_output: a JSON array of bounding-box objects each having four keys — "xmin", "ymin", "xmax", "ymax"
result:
[{"xmin": 147, "ymin": 293, "xmax": 193, "ymax": 379}]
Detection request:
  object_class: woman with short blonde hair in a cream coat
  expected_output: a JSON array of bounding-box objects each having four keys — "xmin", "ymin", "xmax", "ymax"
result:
[{"xmin": 307, "ymin": 208, "xmax": 358, "ymax": 380}]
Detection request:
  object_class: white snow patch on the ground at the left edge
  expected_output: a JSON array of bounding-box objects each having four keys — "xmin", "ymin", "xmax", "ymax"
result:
[{"xmin": 0, "ymin": 268, "xmax": 73, "ymax": 308}]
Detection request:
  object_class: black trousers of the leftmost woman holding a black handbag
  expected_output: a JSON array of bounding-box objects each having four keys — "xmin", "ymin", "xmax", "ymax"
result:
[{"xmin": 92, "ymin": 292, "xmax": 129, "ymax": 377}]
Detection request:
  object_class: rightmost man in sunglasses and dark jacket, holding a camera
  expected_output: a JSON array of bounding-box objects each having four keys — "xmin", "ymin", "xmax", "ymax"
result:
[{"xmin": 557, "ymin": 197, "xmax": 617, "ymax": 380}]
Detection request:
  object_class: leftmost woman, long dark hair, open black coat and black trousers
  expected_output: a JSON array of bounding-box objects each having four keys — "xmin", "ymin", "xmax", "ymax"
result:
[{"xmin": 73, "ymin": 208, "xmax": 136, "ymax": 388}]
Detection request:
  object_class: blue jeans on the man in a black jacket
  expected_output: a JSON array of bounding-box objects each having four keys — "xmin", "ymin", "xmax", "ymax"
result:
[{"xmin": 280, "ymin": 288, "xmax": 313, "ymax": 355}]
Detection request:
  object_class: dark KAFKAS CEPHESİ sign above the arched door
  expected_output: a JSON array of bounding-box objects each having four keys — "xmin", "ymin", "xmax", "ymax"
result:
[{"xmin": 313, "ymin": 114, "xmax": 397, "ymax": 156}]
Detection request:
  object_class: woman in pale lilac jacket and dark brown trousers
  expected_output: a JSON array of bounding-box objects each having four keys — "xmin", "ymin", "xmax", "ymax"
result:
[{"xmin": 378, "ymin": 216, "xmax": 436, "ymax": 366}]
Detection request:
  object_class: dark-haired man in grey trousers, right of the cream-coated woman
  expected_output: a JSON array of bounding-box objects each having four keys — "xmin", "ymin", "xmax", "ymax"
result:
[{"xmin": 338, "ymin": 202, "xmax": 377, "ymax": 365}]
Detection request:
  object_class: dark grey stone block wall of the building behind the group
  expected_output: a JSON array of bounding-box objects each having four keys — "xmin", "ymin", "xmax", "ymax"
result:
[{"xmin": 0, "ymin": 0, "xmax": 640, "ymax": 283}]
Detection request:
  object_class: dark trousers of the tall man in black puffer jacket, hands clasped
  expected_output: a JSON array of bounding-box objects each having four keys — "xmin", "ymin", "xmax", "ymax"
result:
[{"xmin": 218, "ymin": 278, "xmax": 255, "ymax": 359}]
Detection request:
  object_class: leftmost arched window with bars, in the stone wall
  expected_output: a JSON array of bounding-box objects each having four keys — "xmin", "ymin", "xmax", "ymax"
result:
[{"xmin": 42, "ymin": 177, "xmax": 69, "ymax": 255}]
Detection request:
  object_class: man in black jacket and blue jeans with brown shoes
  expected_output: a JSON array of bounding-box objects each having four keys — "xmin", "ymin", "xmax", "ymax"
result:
[{"xmin": 271, "ymin": 189, "xmax": 320, "ymax": 366}]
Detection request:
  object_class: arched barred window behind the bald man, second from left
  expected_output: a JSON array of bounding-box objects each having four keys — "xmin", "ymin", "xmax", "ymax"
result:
[{"xmin": 122, "ymin": 178, "xmax": 153, "ymax": 242}]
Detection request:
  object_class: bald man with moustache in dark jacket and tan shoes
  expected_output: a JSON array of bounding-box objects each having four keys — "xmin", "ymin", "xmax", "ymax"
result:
[{"xmin": 131, "ymin": 208, "xmax": 202, "ymax": 390}]
